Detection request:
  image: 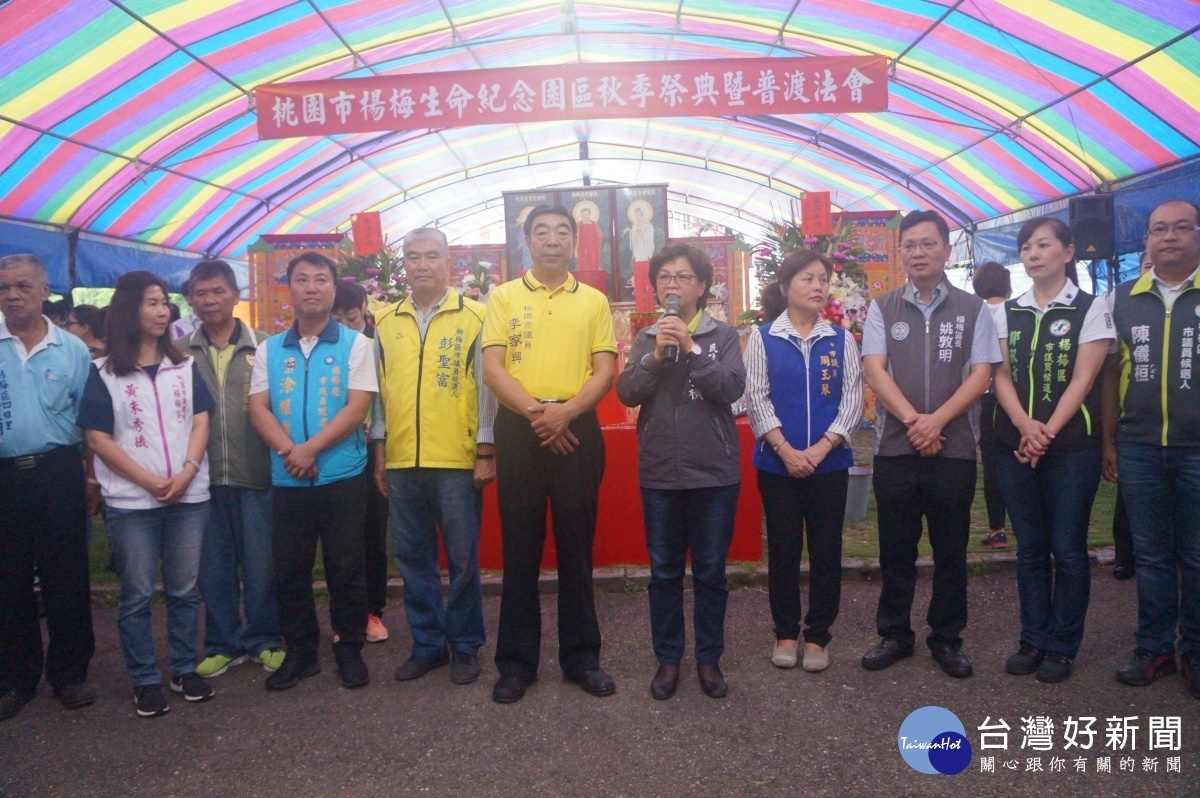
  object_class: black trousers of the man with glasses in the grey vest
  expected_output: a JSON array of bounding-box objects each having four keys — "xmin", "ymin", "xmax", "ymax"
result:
[{"xmin": 874, "ymin": 455, "xmax": 976, "ymax": 647}]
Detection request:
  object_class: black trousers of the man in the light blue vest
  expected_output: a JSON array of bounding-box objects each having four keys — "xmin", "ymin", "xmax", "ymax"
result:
[{"xmin": 271, "ymin": 478, "xmax": 367, "ymax": 655}]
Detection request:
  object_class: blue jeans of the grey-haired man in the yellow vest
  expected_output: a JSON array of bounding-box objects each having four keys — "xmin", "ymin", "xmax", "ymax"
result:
[{"xmin": 388, "ymin": 468, "xmax": 486, "ymax": 659}]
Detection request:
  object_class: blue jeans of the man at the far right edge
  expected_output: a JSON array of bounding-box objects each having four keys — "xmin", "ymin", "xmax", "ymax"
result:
[{"xmin": 1117, "ymin": 443, "xmax": 1200, "ymax": 654}]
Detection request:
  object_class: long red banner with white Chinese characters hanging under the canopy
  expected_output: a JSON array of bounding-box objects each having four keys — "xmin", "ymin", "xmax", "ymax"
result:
[{"xmin": 254, "ymin": 55, "xmax": 888, "ymax": 139}]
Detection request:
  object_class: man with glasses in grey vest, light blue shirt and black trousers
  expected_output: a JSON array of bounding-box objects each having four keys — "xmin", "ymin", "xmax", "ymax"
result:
[{"xmin": 863, "ymin": 211, "xmax": 1001, "ymax": 678}]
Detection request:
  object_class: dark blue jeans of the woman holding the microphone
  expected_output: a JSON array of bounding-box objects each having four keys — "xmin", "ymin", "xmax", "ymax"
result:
[{"xmin": 642, "ymin": 485, "xmax": 742, "ymax": 665}]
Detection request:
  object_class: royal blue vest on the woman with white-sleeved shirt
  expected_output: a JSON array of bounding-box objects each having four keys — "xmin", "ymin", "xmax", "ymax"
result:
[{"xmin": 754, "ymin": 328, "xmax": 854, "ymax": 476}]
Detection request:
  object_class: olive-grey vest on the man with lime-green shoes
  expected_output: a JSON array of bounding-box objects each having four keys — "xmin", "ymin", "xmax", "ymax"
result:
[{"xmin": 180, "ymin": 320, "xmax": 271, "ymax": 488}]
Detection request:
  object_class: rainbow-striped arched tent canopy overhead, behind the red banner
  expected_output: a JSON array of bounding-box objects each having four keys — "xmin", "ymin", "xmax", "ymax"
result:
[{"xmin": 0, "ymin": 0, "xmax": 1200, "ymax": 278}]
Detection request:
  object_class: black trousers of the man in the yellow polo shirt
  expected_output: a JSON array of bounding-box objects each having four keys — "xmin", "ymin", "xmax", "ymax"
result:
[{"xmin": 494, "ymin": 407, "xmax": 604, "ymax": 679}]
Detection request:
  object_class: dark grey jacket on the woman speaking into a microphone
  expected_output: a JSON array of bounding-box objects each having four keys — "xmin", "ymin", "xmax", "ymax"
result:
[{"xmin": 617, "ymin": 313, "xmax": 746, "ymax": 491}]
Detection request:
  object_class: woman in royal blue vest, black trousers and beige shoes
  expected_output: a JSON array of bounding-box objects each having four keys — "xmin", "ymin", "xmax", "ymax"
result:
[{"xmin": 745, "ymin": 250, "xmax": 863, "ymax": 672}]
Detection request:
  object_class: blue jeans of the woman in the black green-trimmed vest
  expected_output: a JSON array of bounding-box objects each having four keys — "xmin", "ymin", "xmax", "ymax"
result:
[{"xmin": 996, "ymin": 448, "xmax": 1100, "ymax": 658}]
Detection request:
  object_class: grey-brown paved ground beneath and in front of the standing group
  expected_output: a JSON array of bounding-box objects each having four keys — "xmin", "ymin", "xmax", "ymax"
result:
[{"xmin": 0, "ymin": 568, "xmax": 1200, "ymax": 798}]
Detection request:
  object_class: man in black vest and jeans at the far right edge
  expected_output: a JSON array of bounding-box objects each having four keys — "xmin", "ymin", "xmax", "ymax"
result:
[{"xmin": 1104, "ymin": 199, "xmax": 1200, "ymax": 698}]
